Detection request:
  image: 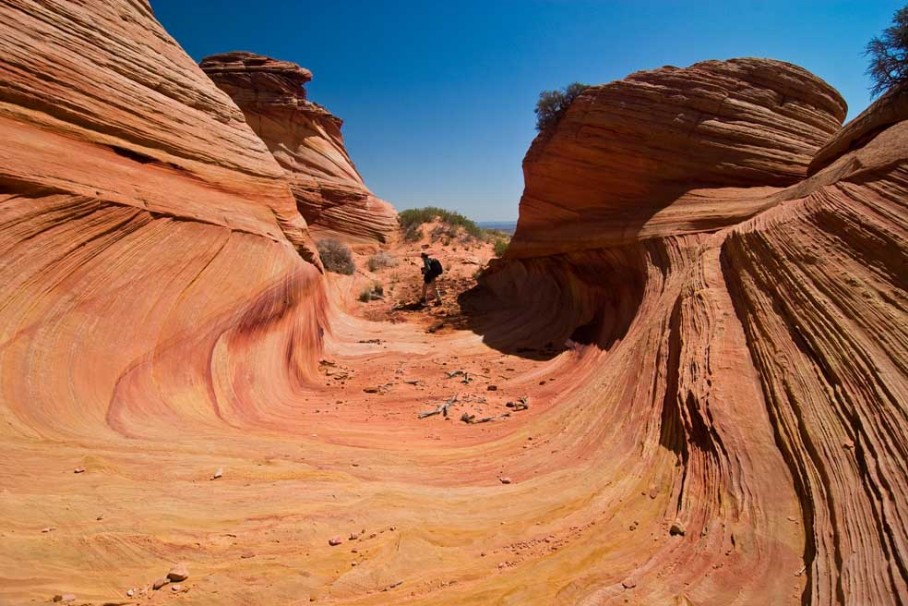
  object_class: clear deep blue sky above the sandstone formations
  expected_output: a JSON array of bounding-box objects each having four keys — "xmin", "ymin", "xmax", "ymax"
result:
[{"xmin": 151, "ymin": 0, "xmax": 905, "ymax": 221}]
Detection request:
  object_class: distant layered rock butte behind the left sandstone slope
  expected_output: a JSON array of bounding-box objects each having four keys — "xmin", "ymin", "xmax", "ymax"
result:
[{"xmin": 201, "ymin": 52, "xmax": 397, "ymax": 242}]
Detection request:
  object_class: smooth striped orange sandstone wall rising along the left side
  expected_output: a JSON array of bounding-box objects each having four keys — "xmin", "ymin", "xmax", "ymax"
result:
[{"xmin": 0, "ymin": 1, "xmax": 324, "ymax": 436}]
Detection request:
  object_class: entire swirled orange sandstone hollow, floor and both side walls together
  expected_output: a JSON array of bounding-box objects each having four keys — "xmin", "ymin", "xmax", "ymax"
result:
[{"xmin": 0, "ymin": 0, "xmax": 908, "ymax": 605}]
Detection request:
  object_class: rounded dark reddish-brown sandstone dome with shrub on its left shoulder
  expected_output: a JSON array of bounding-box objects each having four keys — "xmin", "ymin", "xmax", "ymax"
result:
[{"xmin": 509, "ymin": 59, "xmax": 845, "ymax": 257}]
